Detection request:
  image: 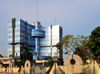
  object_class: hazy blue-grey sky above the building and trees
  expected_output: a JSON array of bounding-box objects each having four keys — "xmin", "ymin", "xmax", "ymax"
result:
[{"xmin": 0, "ymin": 0, "xmax": 100, "ymax": 56}]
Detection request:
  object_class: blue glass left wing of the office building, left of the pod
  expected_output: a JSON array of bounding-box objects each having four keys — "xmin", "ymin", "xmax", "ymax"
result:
[{"xmin": 8, "ymin": 19, "xmax": 35, "ymax": 58}]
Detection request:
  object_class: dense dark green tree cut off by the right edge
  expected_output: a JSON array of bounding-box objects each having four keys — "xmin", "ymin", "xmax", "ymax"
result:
[{"xmin": 89, "ymin": 26, "xmax": 100, "ymax": 60}]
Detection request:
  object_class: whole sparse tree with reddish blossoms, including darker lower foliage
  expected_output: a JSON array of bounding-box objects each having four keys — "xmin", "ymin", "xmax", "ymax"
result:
[{"xmin": 56, "ymin": 35, "xmax": 91, "ymax": 61}]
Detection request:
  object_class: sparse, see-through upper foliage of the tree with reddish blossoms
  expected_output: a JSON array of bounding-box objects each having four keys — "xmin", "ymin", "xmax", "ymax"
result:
[{"xmin": 56, "ymin": 35, "xmax": 89, "ymax": 54}]
